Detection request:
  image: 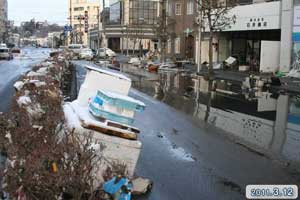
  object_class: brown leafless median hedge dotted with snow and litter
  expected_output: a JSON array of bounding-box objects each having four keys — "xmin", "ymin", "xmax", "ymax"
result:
[{"xmin": 0, "ymin": 56, "xmax": 104, "ymax": 200}]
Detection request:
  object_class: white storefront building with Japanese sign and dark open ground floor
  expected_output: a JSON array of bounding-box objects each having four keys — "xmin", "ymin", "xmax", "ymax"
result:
[{"xmin": 195, "ymin": 0, "xmax": 294, "ymax": 72}]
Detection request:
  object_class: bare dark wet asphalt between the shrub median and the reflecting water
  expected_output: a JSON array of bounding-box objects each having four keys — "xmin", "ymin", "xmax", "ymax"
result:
[{"xmin": 73, "ymin": 61, "xmax": 300, "ymax": 200}]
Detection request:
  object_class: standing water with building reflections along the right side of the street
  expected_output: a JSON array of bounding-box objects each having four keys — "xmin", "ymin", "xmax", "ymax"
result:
[{"xmin": 123, "ymin": 66, "xmax": 300, "ymax": 167}]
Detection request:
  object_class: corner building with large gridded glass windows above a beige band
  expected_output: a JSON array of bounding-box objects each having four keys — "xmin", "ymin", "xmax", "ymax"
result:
[{"xmin": 103, "ymin": 0, "xmax": 160, "ymax": 52}]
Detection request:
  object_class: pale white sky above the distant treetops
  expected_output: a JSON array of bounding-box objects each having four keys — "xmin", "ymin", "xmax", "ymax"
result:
[{"xmin": 8, "ymin": 0, "xmax": 68, "ymax": 25}]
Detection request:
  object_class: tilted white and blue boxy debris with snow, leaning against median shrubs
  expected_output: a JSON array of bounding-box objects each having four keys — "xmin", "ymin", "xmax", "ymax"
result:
[{"xmin": 64, "ymin": 66, "xmax": 145, "ymax": 179}]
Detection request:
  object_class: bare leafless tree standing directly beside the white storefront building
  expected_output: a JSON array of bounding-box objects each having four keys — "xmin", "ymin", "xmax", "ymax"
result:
[{"xmin": 196, "ymin": 0, "xmax": 237, "ymax": 77}]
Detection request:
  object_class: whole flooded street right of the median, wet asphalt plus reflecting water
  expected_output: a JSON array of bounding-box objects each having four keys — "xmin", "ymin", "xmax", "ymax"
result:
[{"xmin": 75, "ymin": 61, "xmax": 300, "ymax": 200}]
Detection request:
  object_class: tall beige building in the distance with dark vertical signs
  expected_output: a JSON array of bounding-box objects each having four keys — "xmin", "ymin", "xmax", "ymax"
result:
[{"xmin": 69, "ymin": 0, "xmax": 102, "ymax": 45}]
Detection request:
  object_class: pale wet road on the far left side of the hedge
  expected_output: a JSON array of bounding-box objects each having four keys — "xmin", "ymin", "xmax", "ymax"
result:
[{"xmin": 0, "ymin": 48, "xmax": 50, "ymax": 112}]
